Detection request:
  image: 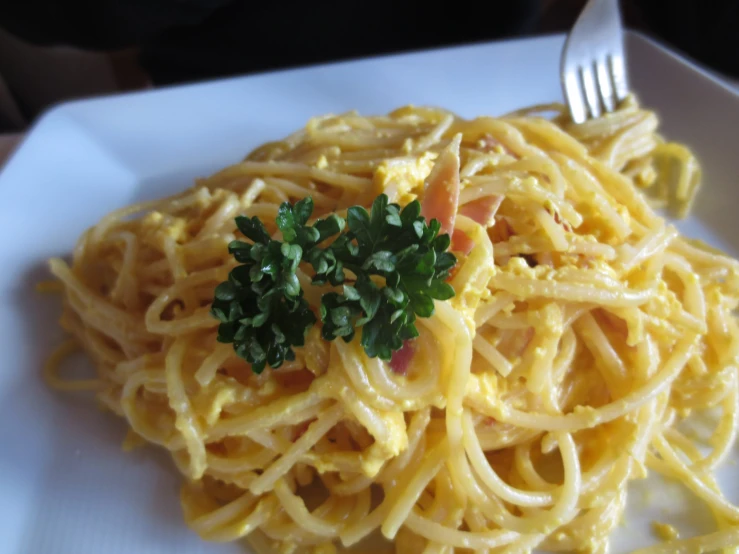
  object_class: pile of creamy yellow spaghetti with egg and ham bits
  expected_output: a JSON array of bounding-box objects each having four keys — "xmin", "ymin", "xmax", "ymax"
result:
[{"xmin": 46, "ymin": 100, "xmax": 739, "ymax": 554}]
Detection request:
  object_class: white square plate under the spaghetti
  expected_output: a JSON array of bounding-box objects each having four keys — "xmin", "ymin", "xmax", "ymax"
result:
[{"xmin": 0, "ymin": 34, "xmax": 739, "ymax": 554}]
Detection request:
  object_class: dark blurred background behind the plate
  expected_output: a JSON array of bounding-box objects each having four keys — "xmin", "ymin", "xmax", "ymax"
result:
[{"xmin": 0, "ymin": 0, "xmax": 739, "ymax": 131}]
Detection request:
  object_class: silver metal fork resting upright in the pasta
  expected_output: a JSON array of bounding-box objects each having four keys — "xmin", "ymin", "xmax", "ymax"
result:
[{"xmin": 560, "ymin": 0, "xmax": 629, "ymax": 123}]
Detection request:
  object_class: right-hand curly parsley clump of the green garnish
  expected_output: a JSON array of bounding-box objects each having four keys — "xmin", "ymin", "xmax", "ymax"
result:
[{"xmin": 309, "ymin": 194, "xmax": 456, "ymax": 360}]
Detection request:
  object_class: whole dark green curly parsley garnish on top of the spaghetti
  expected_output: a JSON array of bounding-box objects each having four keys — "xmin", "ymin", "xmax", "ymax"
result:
[{"xmin": 211, "ymin": 194, "xmax": 457, "ymax": 373}]
